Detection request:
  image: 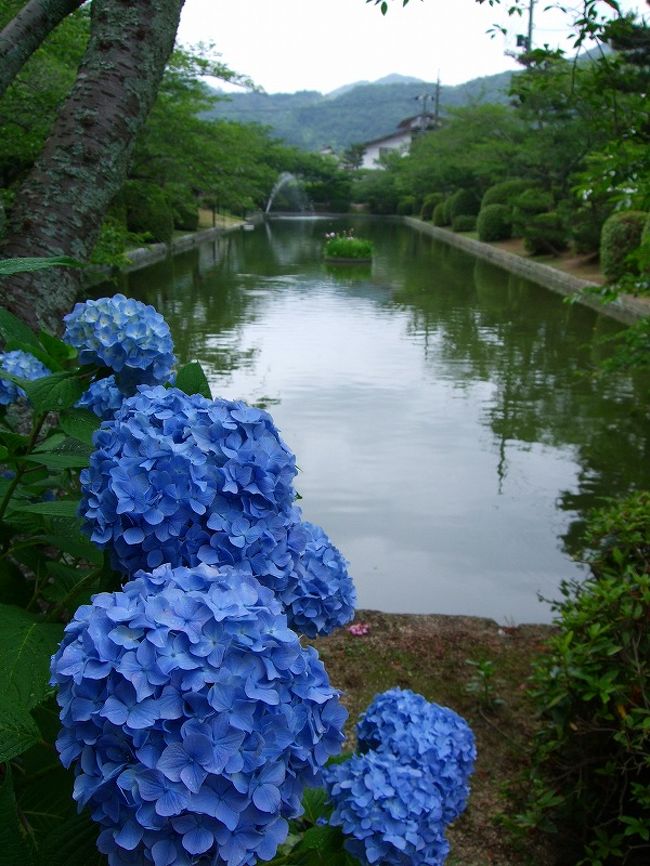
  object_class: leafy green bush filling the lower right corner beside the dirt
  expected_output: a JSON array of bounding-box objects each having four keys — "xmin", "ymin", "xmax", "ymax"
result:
[{"xmin": 514, "ymin": 492, "xmax": 650, "ymax": 866}]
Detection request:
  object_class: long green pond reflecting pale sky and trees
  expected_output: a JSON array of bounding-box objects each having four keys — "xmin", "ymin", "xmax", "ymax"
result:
[{"xmin": 100, "ymin": 219, "xmax": 650, "ymax": 623}]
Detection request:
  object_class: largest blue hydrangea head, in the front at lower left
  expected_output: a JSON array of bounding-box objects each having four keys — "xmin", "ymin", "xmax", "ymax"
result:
[{"xmin": 52, "ymin": 565, "xmax": 346, "ymax": 866}]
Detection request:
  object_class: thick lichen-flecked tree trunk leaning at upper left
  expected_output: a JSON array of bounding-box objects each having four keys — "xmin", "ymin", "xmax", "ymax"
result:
[{"xmin": 2, "ymin": 0, "xmax": 184, "ymax": 330}]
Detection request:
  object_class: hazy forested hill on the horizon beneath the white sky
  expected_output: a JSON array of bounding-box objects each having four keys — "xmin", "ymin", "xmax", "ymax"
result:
[{"xmin": 202, "ymin": 72, "xmax": 512, "ymax": 151}]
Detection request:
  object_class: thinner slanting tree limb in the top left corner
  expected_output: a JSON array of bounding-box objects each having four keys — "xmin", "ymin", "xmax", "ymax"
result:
[{"xmin": 0, "ymin": 0, "xmax": 84, "ymax": 97}]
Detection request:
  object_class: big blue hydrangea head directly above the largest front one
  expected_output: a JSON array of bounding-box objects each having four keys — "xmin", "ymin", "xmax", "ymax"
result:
[{"xmin": 80, "ymin": 387, "xmax": 298, "ymax": 593}]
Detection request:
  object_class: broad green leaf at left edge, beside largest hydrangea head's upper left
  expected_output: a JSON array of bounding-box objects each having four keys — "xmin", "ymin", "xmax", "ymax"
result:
[{"xmin": 0, "ymin": 604, "xmax": 63, "ymax": 715}]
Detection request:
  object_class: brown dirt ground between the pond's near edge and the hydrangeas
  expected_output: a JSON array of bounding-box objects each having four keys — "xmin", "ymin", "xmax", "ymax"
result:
[{"xmin": 313, "ymin": 611, "xmax": 553, "ymax": 866}]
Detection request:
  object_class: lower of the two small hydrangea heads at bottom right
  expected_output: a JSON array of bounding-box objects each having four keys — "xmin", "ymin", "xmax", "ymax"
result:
[{"xmin": 324, "ymin": 752, "xmax": 449, "ymax": 866}]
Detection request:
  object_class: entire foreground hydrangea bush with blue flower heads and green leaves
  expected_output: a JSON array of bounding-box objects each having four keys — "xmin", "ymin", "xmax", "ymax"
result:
[{"xmin": 0, "ymin": 286, "xmax": 475, "ymax": 866}]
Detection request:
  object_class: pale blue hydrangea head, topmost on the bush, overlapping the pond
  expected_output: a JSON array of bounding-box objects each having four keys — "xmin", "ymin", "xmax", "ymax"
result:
[{"xmin": 63, "ymin": 294, "xmax": 176, "ymax": 393}]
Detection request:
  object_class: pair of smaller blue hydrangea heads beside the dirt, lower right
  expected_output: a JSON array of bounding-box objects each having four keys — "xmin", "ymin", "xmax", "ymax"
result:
[{"xmin": 325, "ymin": 688, "xmax": 476, "ymax": 866}]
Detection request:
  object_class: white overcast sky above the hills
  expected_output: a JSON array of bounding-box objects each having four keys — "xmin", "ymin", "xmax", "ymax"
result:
[{"xmin": 178, "ymin": 0, "xmax": 650, "ymax": 93}]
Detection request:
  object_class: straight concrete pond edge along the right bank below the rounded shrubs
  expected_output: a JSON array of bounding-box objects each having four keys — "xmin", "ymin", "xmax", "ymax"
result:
[{"xmin": 401, "ymin": 216, "xmax": 650, "ymax": 325}]
